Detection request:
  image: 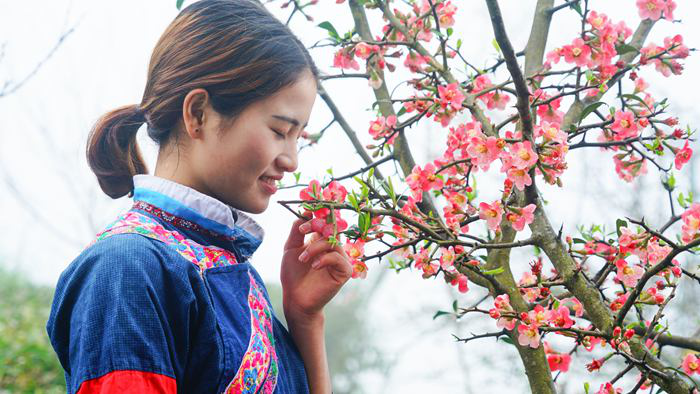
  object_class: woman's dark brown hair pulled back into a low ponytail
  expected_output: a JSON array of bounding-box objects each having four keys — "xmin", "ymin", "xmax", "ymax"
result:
[{"xmin": 87, "ymin": 0, "xmax": 318, "ymax": 198}]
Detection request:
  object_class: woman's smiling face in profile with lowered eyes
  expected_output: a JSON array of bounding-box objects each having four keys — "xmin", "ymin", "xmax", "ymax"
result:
[{"xmin": 176, "ymin": 72, "xmax": 317, "ymax": 213}]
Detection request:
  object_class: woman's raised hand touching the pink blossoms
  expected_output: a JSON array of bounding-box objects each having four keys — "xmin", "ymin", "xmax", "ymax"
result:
[{"xmin": 281, "ymin": 219, "xmax": 352, "ymax": 320}]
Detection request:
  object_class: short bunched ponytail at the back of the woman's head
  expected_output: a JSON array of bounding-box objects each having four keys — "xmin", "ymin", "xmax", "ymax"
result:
[{"xmin": 87, "ymin": 105, "xmax": 148, "ymax": 198}]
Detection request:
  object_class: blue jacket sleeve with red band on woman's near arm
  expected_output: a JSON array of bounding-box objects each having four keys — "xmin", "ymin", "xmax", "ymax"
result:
[{"xmin": 47, "ymin": 234, "xmax": 197, "ymax": 394}]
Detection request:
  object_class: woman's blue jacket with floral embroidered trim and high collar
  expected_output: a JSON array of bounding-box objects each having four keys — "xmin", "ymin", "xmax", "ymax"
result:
[{"xmin": 46, "ymin": 175, "xmax": 308, "ymax": 394}]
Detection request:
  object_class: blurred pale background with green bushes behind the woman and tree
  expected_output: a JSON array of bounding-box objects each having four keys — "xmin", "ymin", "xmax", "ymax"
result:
[{"xmin": 0, "ymin": 0, "xmax": 700, "ymax": 394}]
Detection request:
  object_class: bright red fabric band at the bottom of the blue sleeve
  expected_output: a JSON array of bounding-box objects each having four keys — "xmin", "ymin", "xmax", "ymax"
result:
[{"xmin": 77, "ymin": 370, "xmax": 177, "ymax": 394}]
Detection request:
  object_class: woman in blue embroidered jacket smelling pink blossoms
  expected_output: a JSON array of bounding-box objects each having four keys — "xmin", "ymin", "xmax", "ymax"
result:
[{"xmin": 47, "ymin": 0, "xmax": 352, "ymax": 394}]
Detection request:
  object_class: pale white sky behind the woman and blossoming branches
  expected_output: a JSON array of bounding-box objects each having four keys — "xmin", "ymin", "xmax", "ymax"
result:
[{"xmin": 0, "ymin": 0, "xmax": 700, "ymax": 393}]
